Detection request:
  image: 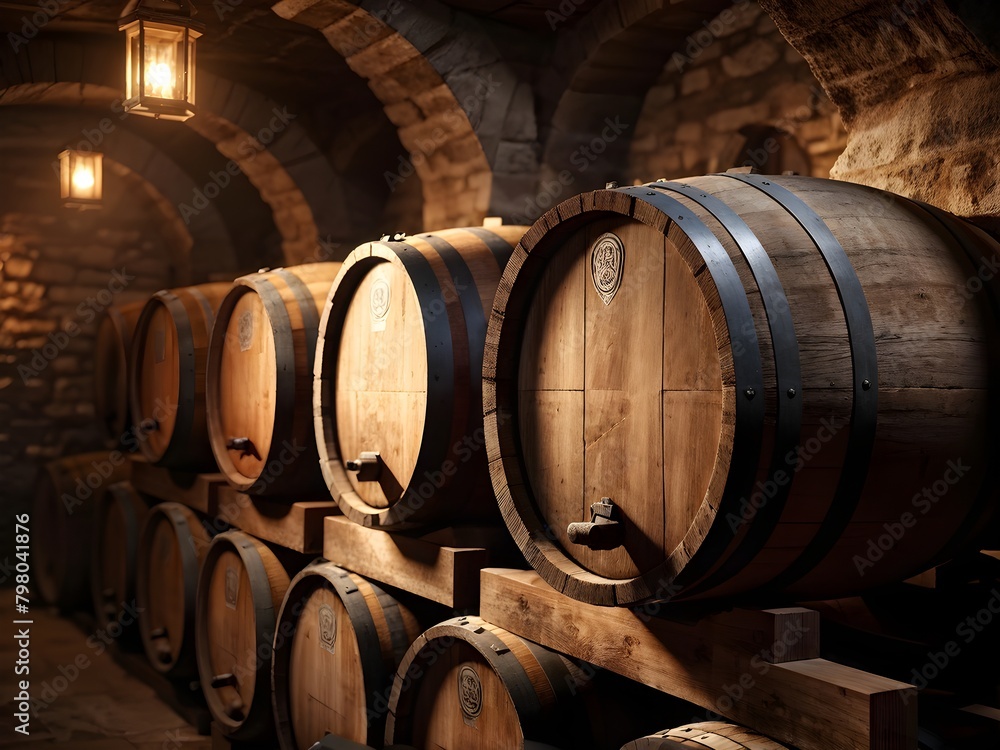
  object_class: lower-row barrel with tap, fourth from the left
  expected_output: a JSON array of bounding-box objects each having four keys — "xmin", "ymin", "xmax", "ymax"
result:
[{"xmin": 195, "ymin": 531, "xmax": 289, "ymax": 742}]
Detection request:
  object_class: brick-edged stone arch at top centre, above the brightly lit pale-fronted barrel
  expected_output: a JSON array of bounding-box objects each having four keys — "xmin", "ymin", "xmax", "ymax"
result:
[{"xmin": 272, "ymin": 0, "xmax": 500, "ymax": 229}]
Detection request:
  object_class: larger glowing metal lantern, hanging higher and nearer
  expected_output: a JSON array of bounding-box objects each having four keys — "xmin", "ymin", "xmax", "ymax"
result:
[{"xmin": 118, "ymin": 0, "xmax": 204, "ymax": 120}]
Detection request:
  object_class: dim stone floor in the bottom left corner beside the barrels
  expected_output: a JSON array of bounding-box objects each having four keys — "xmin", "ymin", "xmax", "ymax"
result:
[{"xmin": 0, "ymin": 600, "xmax": 211, "ymax": 750}]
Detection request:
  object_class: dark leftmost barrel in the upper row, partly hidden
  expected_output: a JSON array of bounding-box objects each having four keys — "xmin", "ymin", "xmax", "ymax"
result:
[{"xmin": 94, "ymin": 302, "xmax": 145, "ymax": 440}]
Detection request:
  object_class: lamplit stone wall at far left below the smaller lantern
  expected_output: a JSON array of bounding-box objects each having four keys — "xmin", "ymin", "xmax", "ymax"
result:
[{"xmin": 0, "ymin": 170, "xmax": 178, "ymax": 534}]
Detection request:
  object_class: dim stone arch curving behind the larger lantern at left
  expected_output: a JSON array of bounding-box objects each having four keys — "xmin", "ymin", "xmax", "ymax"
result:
[{"xmin": 0, "ymin": 37, "xmax": 349, "ymax": 262}]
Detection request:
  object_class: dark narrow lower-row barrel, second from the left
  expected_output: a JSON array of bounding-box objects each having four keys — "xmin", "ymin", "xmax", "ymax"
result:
[{"xmin": 90, "ymin": 482, "xmax": 149, "ymax": 645}]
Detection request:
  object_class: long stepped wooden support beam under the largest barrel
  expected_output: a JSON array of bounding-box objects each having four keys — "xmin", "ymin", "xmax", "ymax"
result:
[{"xmin": 481, "ymin": 569, "xmax": 917, "ymax": 750}]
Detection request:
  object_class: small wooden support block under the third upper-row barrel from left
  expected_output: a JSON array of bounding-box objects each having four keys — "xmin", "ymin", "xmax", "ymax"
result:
[{"xmin": 215, "ymin": 485, "xmax": 340, "ymax": 555}]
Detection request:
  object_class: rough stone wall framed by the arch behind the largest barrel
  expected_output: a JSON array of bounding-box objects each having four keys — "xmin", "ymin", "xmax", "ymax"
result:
[{"xmin": 629, "ymin": 0, "xmax": 847, "ymax": 182}]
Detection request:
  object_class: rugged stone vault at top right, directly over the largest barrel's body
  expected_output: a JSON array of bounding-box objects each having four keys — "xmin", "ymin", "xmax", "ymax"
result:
[{"xmin": 761, "ymin": 0, "xmax": 1000, "ymax": 231}]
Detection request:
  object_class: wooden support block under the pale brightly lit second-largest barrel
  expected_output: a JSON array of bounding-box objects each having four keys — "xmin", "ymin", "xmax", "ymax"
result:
[{"xmin": 323, "ymin": 516, "xmax": 510, "ymax": 610}]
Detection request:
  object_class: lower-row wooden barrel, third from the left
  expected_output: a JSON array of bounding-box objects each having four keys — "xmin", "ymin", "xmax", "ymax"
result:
[{"xmin": 136, "ymin": 503, "xmax": 211, "ymax": 679}]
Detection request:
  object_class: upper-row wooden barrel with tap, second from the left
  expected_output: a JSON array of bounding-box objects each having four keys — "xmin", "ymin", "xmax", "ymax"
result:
[{"xmin": 129, "ymin": 283, "xmax": 231, "ymax": 471}]
